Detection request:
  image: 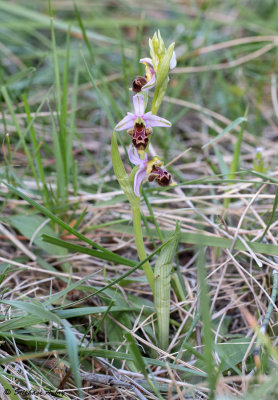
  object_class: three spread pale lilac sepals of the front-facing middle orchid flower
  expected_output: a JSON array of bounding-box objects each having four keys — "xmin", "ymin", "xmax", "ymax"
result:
[{"xmin": 115, "ymin": 95, "xmax": 172, "ymax": 131}]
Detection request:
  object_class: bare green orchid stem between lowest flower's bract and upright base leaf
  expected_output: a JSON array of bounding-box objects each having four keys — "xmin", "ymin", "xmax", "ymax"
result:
[{"xmin": 132, "ymin": 207, "xmax": 154, "ymax": 293}]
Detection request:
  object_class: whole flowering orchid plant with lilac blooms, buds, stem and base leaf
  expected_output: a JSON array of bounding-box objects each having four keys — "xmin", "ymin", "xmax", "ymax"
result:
[{"xmin": 112, "ymin": 31, "xmax": 177, "ymax": 340}]
